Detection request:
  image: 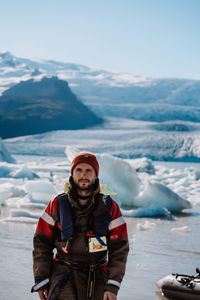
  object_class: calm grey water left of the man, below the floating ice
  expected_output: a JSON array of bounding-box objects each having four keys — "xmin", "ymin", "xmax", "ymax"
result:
[{"xmin": 0, "ymin": 223, "xmax": 38, "ymax": 300}]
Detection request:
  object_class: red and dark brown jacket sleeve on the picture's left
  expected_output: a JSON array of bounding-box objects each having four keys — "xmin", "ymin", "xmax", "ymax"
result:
[{"xmin": 32, "ymin": 197, "xmax": 58, "ymax": 292}]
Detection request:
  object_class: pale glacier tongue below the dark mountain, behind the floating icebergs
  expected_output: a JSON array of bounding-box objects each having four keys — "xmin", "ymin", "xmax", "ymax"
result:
[{"xmin": 4, "ymin": 118, "xmax": 200, "ymax": 162}]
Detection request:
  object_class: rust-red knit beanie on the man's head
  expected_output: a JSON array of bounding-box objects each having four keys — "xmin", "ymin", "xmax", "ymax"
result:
[{"xmin": 71, "ymin": 152, "xmax": 99, "ymax": 176}]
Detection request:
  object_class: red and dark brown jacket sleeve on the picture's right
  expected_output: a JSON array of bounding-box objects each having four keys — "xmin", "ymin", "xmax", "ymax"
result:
[{"xmin": 105, "ymin": 199, "xmax": 129, "ymax": 294}]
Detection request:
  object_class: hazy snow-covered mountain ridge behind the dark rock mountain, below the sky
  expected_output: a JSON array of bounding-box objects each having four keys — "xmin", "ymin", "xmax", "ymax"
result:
[{"xmin": 0, "ymin": 51, "xmax": 200, "ymax": 122}]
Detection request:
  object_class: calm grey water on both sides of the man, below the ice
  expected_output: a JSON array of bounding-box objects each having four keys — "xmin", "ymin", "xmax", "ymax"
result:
[{"xmin": 0, "ymin": 203, "xmax": 200, "ymax": 300}]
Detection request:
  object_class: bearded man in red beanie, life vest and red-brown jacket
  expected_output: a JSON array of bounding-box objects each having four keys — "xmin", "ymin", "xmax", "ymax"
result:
[{"xmin": 32, "ymin": 152, "xmax": 128, "ymax": 300}]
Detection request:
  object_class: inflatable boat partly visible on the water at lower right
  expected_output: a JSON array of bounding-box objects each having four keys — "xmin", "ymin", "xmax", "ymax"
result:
[{"xmin": 157, "ymin": 269, "xmax": 200, "ymax": 300}]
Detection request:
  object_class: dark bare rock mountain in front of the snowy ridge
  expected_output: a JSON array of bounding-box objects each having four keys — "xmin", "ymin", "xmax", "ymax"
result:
[{"xmin": 0, "ymin": 77, "xmax": 103, "ymax": 138}]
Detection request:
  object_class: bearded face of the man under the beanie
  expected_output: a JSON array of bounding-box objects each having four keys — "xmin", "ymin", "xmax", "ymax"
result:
[{"xmin": 72, "ymin": 163, "xmax": 97, "ymax": 191}]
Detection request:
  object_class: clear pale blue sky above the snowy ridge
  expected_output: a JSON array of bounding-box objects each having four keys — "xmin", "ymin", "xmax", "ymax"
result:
[{"xmin": 0, "ymin": 0, "xmax": 200, "ymax": 79}]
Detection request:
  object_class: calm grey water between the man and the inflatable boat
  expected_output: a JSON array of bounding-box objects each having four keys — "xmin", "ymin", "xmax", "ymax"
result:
[{"xmin": 123, "ymin": 214, "xmax": 200, "ymax": 300}]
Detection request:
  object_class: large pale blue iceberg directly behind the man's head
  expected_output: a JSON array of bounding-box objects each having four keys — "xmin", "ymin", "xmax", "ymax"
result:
[{"xmin": 65, "ymin": 147, "xmax": 191, "ymax": 217}]
